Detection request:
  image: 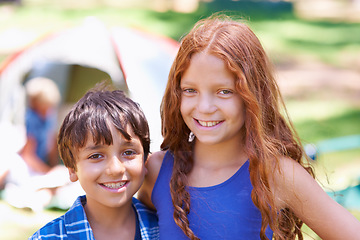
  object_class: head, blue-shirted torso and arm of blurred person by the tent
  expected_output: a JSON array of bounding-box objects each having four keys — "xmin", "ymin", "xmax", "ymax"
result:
[{"xmin": 20, "ymin": 77, "xmax": 61, "ymax": 174}]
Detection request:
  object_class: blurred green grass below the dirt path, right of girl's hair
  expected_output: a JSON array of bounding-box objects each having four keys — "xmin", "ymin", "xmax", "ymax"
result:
[{"xmin": 287, "ymin": 99, "xmax": 360, "ymax": 186}]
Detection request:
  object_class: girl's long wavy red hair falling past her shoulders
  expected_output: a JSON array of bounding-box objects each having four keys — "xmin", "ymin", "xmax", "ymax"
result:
[{"xmin": 161, "ymin": 16, "xmax": 313, "ymax": 239}]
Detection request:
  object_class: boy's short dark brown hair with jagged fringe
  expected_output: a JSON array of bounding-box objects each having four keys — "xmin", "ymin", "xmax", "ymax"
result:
[{"xmin": 58, "ymin": 87, "xmax": 150, "ymax": 170}]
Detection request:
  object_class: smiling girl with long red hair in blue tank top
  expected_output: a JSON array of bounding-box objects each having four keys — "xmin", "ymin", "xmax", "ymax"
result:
[{"xmin": 139, "ymin": 14, "xmax": 360, "ymax": 239}]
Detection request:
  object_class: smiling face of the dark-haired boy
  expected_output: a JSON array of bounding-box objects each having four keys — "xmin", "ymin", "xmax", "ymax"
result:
[{"xmin": 69, "ymin": 124, "xmax": 146, "ymax": 208}]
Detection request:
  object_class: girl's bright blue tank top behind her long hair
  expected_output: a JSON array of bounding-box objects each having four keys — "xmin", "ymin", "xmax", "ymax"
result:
[{"xmin": 151, "ymin": 151, "xmax": 273, "ymax": 240}]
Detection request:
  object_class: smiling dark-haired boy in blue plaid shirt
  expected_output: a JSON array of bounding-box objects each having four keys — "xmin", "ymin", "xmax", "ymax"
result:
[{"xmin": 29, "ymin": 86, "xmax": 158, "ymax": 240}]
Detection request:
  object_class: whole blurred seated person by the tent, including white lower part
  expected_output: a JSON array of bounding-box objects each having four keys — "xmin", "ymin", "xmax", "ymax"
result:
[{"xmin": 0, "ymin": 77, "xmax": 75, "ymax": 211}]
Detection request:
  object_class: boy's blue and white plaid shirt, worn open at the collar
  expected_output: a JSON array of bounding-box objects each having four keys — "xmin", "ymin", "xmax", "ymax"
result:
[{"xmin": 29, "ymin": 196, "xmax": 159, "ymax": 240}]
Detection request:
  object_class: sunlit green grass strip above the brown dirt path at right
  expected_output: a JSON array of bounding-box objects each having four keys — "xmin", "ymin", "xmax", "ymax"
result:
[{"xmin": 253, "ymin": 19, "xmax": 360, "ymax": 67}]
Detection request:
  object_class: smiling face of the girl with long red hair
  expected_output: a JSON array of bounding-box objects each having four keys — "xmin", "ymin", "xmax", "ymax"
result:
[{"xmin": 180, "ymin": 52, "xmax": 245, "ymax": 144}]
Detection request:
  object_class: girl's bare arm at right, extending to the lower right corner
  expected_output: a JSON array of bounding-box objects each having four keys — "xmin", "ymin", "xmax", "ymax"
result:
[{"xmin": 275, "ymin": 159, "xmax": 360, "ymax": 239}]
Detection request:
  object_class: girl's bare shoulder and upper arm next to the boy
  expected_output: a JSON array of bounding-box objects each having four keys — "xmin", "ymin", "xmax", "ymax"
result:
[{"xmin": 138, "ymin": 151, "xmax": 165, "ymax": 210}]
